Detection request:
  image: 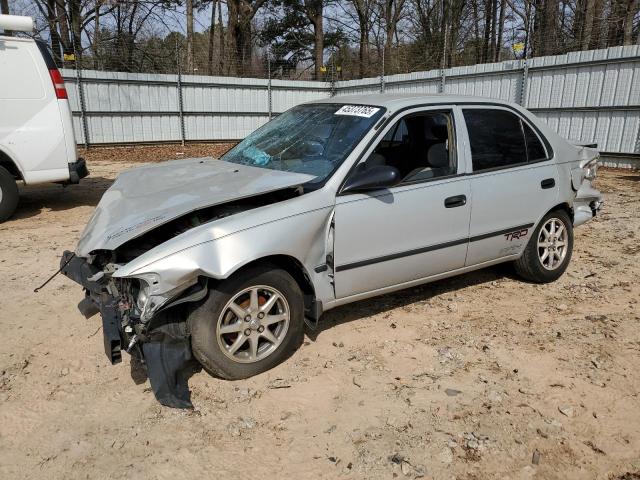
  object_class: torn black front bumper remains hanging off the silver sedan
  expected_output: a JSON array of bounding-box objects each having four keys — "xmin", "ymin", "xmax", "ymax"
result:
[{"xmin": 60, "ymin": 251, "xmax": 199, "ymax": 408}]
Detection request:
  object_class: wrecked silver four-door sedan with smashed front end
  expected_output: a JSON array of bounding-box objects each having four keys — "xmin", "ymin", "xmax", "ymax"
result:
[{"xmin": 61, "ymin": 95, "xmax": 602, "ymax": 406}]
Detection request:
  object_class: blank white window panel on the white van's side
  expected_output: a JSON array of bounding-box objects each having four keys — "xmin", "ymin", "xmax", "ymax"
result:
[{"xmin": 0, "ymin": 40, "xmax": 45, "ymax": 100}]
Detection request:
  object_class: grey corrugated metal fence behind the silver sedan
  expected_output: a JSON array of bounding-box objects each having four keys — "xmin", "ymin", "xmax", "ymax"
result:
[{"xmin": 63, "ymin": 45, "xmax": 640, "ymax": 158}]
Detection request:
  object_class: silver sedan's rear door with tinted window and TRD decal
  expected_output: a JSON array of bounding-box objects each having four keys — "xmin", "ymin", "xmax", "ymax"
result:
[{"xmin": 462, "ymin": 105, "xmax": 558, "ymax": 266}]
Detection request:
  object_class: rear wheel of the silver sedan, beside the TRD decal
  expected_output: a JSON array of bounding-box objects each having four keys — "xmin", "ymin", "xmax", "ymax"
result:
[{"xmin": 515, "ymin": 210, "xmax": 573, "ymax": 283}]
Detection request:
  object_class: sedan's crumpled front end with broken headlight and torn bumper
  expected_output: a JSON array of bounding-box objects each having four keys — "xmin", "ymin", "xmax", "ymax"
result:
[{"xmin": 60, "ymin": 251, "xmax": 202, "ymax": 408}]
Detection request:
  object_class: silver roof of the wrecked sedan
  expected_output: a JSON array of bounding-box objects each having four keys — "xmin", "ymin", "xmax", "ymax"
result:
[{"xmin": 309, "ymin": 93, "xmax": 518, "ymax": 110}]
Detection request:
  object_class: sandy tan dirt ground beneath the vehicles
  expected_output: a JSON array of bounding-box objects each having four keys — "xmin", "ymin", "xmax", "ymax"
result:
[{"xmin": 0, "ymin": 146, "xmax": 640, "ymax": 480}]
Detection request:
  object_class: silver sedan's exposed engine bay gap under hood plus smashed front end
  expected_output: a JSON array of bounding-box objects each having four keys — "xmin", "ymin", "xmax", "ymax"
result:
[{"xmin": 61, "ymin": 187, "xmax": 302, "ymax": 408}]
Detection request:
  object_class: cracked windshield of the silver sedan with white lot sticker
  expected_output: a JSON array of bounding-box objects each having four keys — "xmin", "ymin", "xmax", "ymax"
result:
[{"xmin": 222, "ymin": 104, "xmax": 384, "ymax": 183}]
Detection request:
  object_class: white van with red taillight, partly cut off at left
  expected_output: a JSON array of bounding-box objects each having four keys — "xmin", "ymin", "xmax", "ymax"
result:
[{"xmin": 0, "ymin": 15, "xmax": 89, "ymax": 222}]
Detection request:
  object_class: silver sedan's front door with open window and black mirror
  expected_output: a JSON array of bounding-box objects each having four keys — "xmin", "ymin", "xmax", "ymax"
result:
[{"xmin": 334, "ymin": 107, "xmax": 471, "ymax": 298}]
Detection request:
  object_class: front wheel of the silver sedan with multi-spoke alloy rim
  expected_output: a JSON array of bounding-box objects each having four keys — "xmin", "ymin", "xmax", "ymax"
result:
[{"xmin": 187, "ymin": 265, "xmax": 304, "ymax": 380}]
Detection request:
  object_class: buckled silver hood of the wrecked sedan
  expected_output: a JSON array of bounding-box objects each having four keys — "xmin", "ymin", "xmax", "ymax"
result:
[{"xmin": 76, "ymin": 158, "xmax": 314, "ymax": 257}]
